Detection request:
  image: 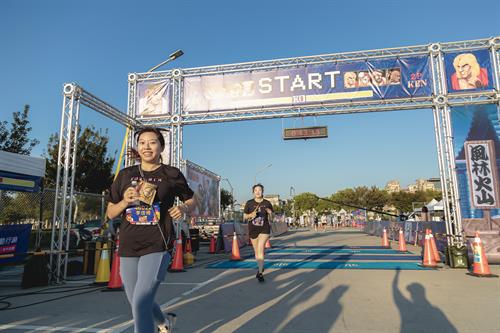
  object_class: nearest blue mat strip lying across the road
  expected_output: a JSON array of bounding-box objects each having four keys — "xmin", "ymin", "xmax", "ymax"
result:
[{"xmin": 207, "ymin": 261, "xmax": 429, "ymax": 270}]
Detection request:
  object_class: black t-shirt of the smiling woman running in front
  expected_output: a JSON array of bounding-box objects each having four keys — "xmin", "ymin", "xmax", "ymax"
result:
[{"xmin": 107, "ymin": 165, "xmax": 193, "ymax": 257}]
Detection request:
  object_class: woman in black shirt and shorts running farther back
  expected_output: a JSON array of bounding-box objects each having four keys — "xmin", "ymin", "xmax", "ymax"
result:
[{"xmin": 243, "ymin": 184, "xmax": 273, "ymax": 282}]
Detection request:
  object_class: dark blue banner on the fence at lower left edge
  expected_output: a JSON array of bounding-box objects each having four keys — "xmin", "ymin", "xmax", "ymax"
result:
[{"xmin": 0, "ymin": 224, "xmax": 31, "ymax": 264}]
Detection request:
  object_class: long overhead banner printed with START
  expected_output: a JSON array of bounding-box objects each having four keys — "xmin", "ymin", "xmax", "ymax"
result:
[{"xmin": 183, "ymin": 56, "xmax": 432, "ymax": 113}]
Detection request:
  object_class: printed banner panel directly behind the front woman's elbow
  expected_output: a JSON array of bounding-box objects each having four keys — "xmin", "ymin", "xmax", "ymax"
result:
[{"xmin": 186, "ymin": 163, "xmax": 220, "ymax": 218}]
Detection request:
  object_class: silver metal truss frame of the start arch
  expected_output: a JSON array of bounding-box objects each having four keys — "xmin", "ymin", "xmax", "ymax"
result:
[{"xmin": 50, "ymin": 37, "xmax": 500, "ymax": 283}]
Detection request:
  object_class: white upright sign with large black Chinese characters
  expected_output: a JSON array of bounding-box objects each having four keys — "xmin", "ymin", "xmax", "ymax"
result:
[{"xmin": 465, "ymin": 140, "xmax": 499, "ymax": 209}]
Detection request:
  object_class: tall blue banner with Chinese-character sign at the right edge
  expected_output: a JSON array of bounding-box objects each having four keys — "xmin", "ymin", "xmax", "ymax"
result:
[{"xmin": 451, "ymin": 104, "xmax": 500, "ymax": 263}]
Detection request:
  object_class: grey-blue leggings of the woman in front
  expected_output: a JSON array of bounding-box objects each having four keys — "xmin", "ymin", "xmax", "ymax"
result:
[{"xmin": 120, "ymin": 252, "xmax": 170, "ymax": 333}]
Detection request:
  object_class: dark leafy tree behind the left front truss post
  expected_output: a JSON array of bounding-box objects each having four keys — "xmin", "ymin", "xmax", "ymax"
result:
[{"xmin": 44, "ymin": 126, "xmax": 116, "ymax": 193}]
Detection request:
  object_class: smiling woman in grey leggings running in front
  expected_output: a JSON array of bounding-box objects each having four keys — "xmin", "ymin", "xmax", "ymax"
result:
[{"xmin": 106, "ymin": 128, "xmax": 196, "ymax": 333}]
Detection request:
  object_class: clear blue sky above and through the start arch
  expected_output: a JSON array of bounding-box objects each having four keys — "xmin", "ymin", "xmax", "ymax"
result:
[{"xmin": 0, "ymin": 0, "xmax": 500, "ymax": 202}]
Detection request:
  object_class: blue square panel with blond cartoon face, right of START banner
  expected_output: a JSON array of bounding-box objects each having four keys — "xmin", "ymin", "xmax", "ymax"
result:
[{"xmin": 444, "ymin": 50, "xmax": 493, "ymax": 93}]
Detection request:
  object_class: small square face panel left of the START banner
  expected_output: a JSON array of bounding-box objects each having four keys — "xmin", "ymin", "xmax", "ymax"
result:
[{"xmin": 137, "ymin": 80, "xmax": 171, "ymax": 117}]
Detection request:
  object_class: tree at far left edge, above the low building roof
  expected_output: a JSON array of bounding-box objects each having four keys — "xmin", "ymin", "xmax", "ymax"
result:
[{"xmin": 0, "ymin": 105, "xmax": 40, "ymax": 155}]
